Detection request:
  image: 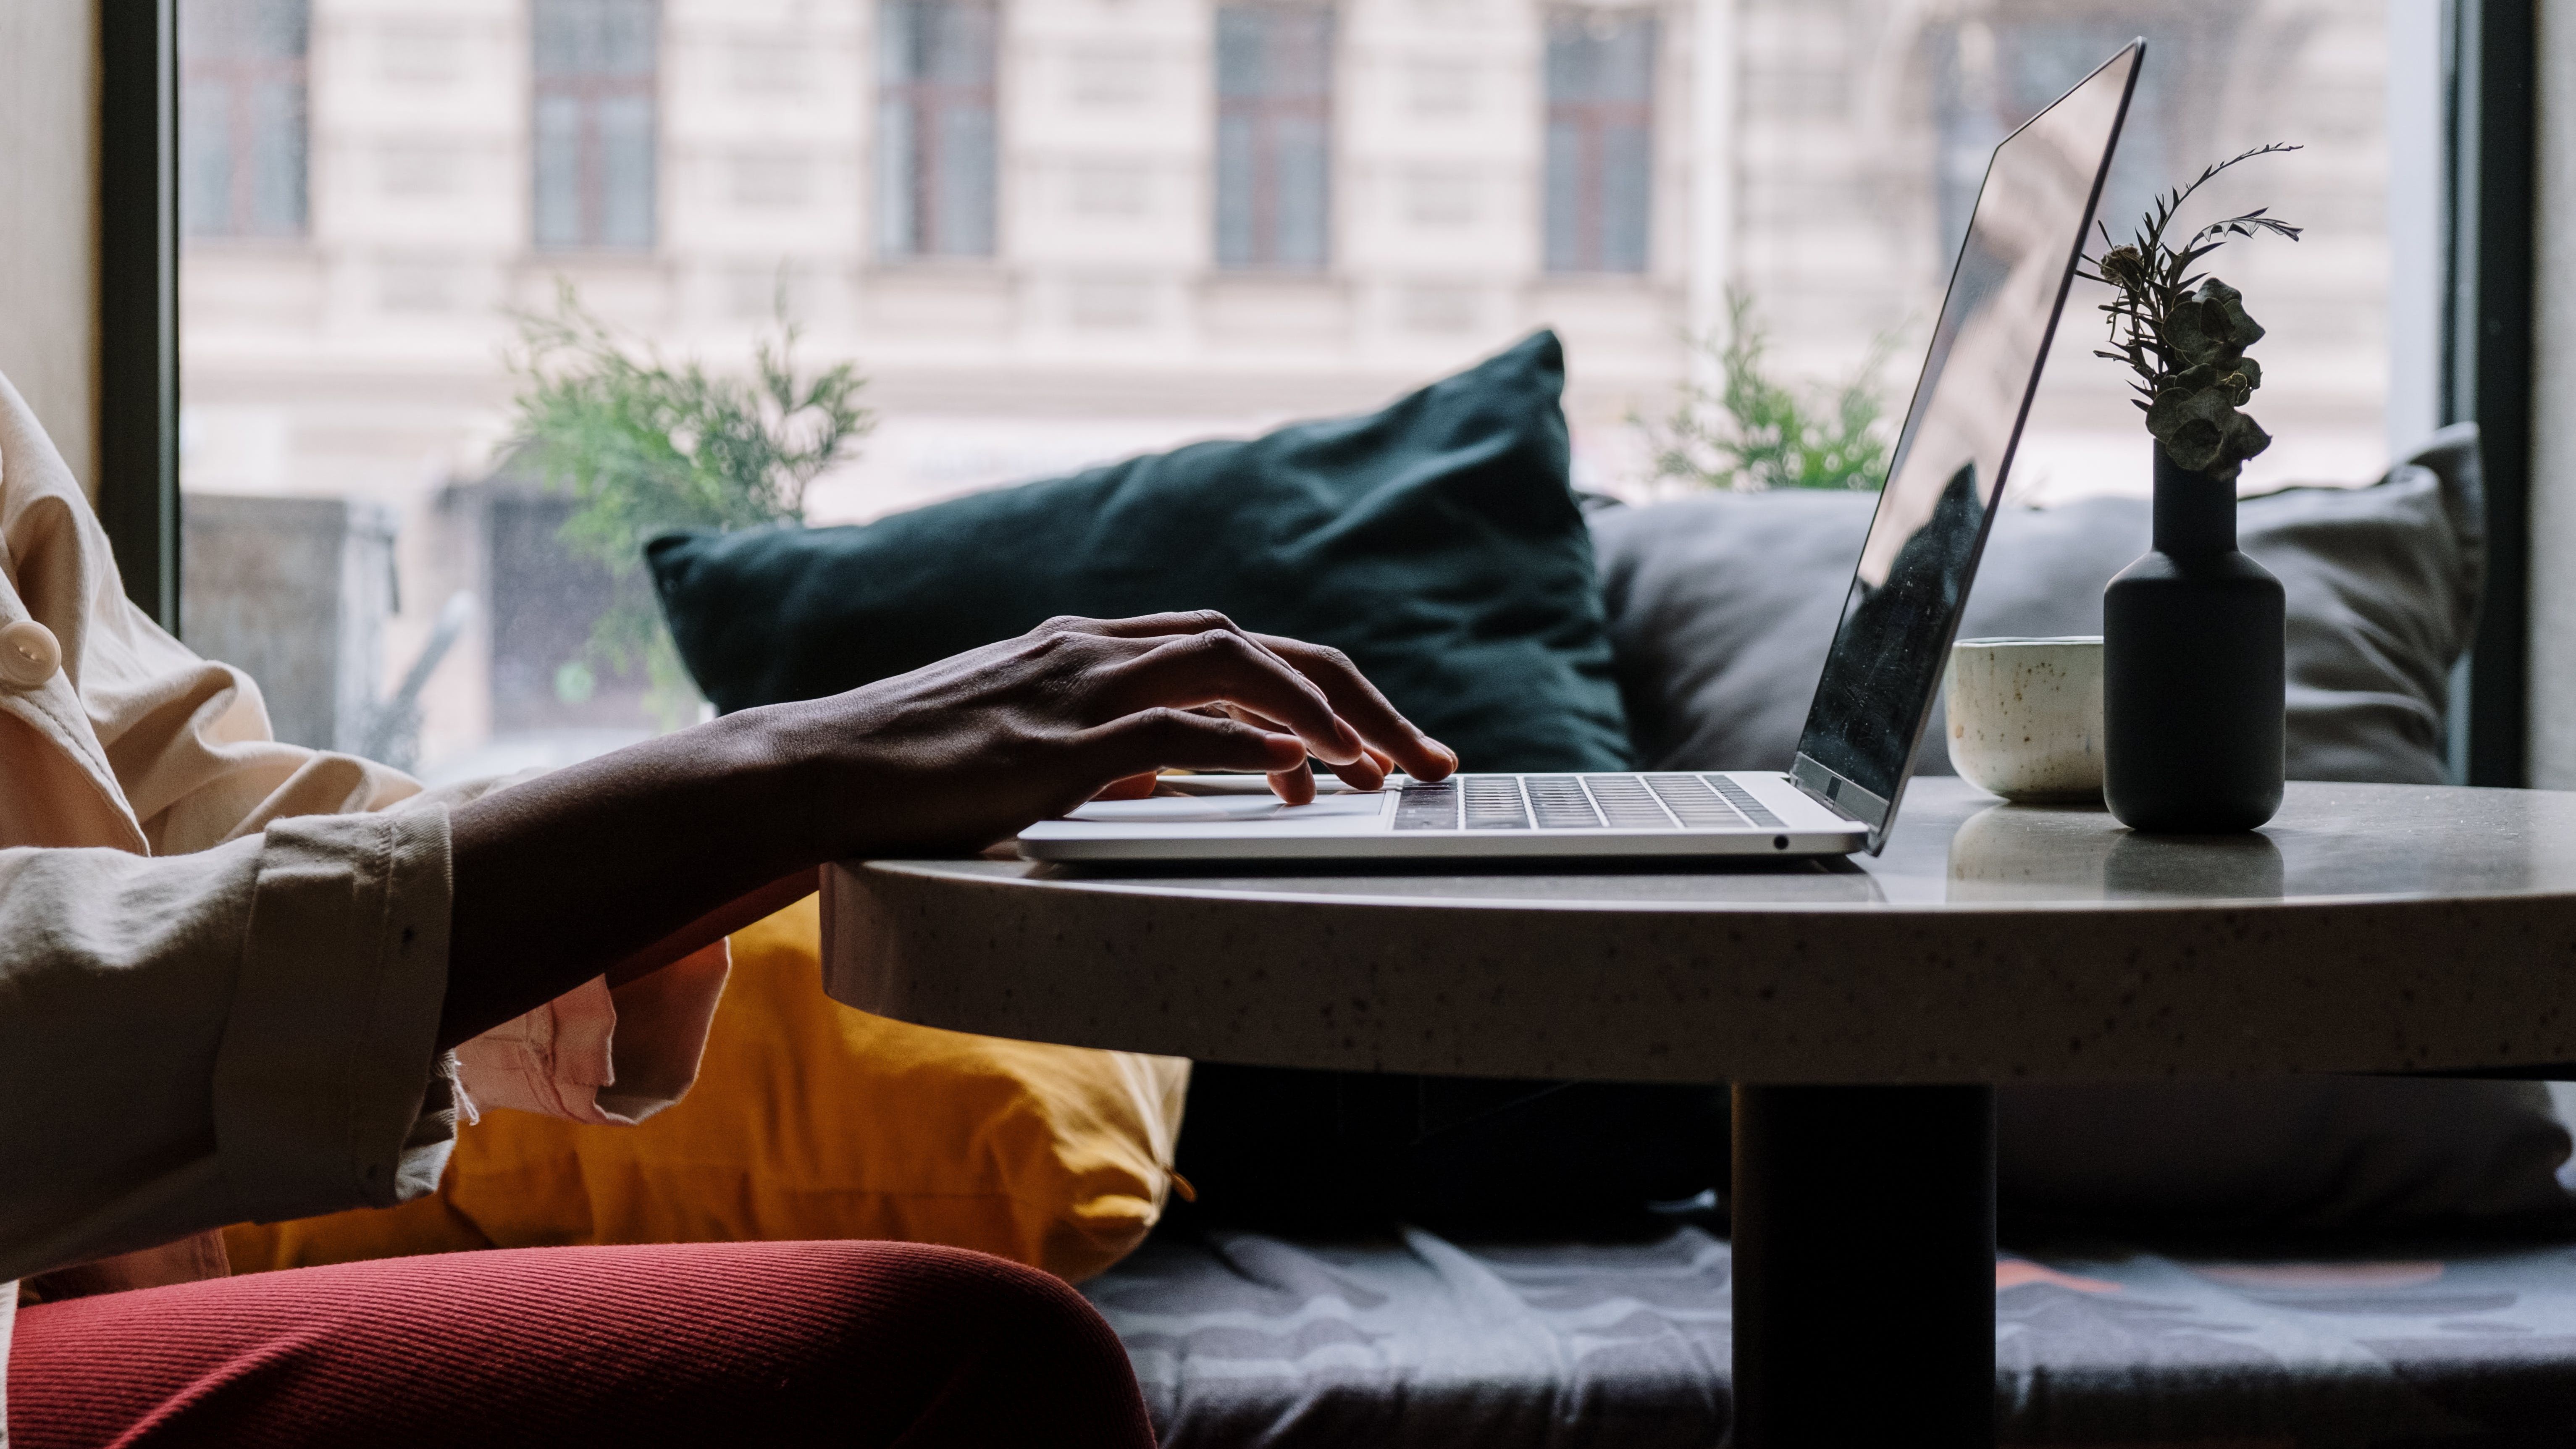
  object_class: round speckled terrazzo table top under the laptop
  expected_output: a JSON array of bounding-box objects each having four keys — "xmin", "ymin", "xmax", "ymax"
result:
[{"xmin": 825, "ymin": 777, "xmax": 2576, "ymax": 1084}]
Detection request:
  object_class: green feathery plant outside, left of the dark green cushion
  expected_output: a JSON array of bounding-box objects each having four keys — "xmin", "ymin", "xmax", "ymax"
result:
[{"xmin": 507, "ymin": 283, "xmax": 876, "ymax": 728}]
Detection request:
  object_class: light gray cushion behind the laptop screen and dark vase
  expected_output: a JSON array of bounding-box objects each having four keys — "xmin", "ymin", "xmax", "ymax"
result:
[{"xmin": 1592, "ymin": 427, "xmax": 2486, "ymax": 785}]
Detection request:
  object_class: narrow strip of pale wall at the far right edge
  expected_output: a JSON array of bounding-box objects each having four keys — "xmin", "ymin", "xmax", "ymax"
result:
[{"xmin": 2530, "ymin": 0, "xmax": 2576, "ymax": 790}]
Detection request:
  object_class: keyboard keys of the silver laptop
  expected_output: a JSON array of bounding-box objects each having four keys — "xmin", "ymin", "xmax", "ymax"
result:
[{"xmin": 1396, "ymin": 772, "xmax": 1780, "ymax": 831}]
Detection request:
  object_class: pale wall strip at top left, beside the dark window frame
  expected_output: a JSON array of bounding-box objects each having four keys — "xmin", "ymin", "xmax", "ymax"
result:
[{"xmin": 0, "ymin": 0, "xmax": 98, "ymax": 494}]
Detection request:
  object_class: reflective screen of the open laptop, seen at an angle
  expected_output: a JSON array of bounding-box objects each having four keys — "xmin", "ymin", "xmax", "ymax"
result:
[{"xmin": 1793, "ymin": 41, "xmax": 2146, "ymax": 849}]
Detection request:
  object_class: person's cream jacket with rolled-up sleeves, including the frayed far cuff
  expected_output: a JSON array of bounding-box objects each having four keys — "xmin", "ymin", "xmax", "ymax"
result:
[{"xmin": 0, "ymin": 360, "xmax": 727, "ymax": 1449}]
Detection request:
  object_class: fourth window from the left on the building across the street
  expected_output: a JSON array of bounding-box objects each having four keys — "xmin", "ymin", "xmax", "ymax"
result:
[{"xmin": 1216, "ymin": 5, "xmax": 1332, "ymax": 268}]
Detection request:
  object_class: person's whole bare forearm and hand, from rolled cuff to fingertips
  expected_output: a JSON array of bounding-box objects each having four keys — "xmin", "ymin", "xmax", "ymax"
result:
[{"xmin": 438, "ymin": 612, "xmax": 1458, "ymax": 1047}]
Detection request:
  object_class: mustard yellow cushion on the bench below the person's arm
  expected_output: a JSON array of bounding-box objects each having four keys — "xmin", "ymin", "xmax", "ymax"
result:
[{"xmin": 224, "ymin": 896, "xmax": 1190, "ymax": 1282}]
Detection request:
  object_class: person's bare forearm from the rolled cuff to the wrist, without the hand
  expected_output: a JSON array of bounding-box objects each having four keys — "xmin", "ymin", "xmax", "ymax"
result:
[{"xmin": 438, "ymin": 710, "xmax": 822, "ymax": 1047}]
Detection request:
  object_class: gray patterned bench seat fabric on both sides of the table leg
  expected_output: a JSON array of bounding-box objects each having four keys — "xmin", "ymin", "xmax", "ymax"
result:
[{"xmin": 1082, "ymin": 1228, "xmax": 2576, "ymax": 1449}]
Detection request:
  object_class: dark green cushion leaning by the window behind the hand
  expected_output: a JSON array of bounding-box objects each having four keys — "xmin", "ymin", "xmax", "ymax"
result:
[{"xmin": 646, "ymin": 332, "xmax": 1631, "ymax": 769}]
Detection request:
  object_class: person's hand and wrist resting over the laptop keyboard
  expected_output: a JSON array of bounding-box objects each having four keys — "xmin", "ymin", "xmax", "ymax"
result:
[{"xmin": 757, "ymin": 612, "xmax": 1458, "ymax": 857}]
